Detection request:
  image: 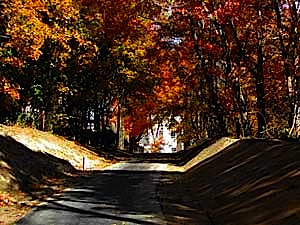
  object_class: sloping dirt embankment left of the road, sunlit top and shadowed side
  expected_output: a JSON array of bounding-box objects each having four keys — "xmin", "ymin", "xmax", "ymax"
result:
[{"xmin": 0, "ymin": 125, "xmax": 115, "ymax": 225}]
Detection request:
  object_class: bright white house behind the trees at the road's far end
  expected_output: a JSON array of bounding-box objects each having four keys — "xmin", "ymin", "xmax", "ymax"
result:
[{"xmin": 139, "ymin": 117, "xmax": 184, "ymax": 153}]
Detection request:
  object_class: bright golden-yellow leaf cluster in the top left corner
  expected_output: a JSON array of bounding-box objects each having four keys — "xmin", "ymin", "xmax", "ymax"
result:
[{"xmin": 4, "ymin": 0, "xmax": 83, "ymax": 64}]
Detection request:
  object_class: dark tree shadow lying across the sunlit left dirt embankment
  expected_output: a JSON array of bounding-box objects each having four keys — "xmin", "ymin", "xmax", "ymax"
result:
[{"xmin": 0, "ymin": 135, "xmax": 76, "ymax": 199}]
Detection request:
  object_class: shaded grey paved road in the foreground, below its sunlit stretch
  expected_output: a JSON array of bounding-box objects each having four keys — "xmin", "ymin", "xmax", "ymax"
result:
[{"xmin": 17, "ymin": 171, "xmax": 208, "ymax": 225}]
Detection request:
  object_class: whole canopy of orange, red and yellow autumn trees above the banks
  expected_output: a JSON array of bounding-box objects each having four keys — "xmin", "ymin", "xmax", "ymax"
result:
[{"xmin": 0, "ymin": 0, "xmax": 300, "ymax": 150}]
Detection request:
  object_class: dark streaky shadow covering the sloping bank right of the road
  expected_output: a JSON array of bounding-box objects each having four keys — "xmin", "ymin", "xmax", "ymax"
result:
[{"xmin": 161, "ymin": 140, "xmax": 300, "ymax": 225}]
